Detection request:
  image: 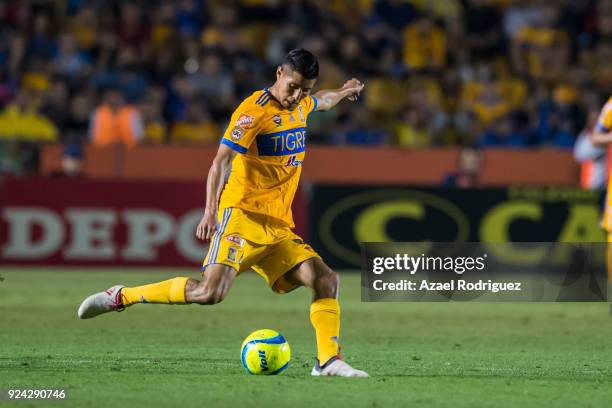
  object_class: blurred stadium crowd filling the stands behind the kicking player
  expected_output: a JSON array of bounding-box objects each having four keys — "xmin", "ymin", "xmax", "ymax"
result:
[{"xmin": 0, "ymin": 0, "xmax": 612, "ymax": 173}]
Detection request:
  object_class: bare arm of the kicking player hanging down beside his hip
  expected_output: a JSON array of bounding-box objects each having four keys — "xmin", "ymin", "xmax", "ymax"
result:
[{"xmin": 196, "ymin": 144, "xmax": 236, "ymax": 241}]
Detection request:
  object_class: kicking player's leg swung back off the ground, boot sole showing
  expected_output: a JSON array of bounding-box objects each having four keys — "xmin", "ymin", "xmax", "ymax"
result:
[{"xmin": 77, "ymin": 264, "xmax": 237, "ymax": 319}]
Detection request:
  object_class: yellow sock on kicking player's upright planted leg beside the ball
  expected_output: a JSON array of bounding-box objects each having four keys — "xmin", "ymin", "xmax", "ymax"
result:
[{"xmin": 310, "ymin": 298, "xmax": 340, "ymax": 365}]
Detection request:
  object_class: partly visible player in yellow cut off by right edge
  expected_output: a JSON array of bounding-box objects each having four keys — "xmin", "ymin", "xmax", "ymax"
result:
[{"xmin": 591, "ymin": 97, "xmax": 612, "ymax": 314}]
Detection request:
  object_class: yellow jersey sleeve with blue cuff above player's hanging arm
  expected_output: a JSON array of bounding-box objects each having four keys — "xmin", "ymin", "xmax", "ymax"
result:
[{"xmin": 221, "ymin": 102, "xmax": 264, "ymax": 153}]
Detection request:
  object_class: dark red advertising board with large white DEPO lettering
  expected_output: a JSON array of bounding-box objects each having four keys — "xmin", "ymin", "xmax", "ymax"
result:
[{"xmin": 0, "ymin": 178, "xmax": 305, "ymax": 266}]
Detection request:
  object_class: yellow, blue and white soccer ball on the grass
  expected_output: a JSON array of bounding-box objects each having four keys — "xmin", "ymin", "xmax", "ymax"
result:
[{"xmin": 240, "ymin": 329, "xmax": 291, "ymax": 375}]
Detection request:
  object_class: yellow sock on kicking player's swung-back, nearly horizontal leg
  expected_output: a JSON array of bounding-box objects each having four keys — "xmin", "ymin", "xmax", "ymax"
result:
[{"xmin": 121, "ymin": 278, "xmax": 189, "ymax": 306}]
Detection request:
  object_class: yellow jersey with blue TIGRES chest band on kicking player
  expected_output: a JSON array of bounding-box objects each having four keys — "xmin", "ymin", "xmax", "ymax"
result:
[{"xmin": 219, "ymin": 88, "xmax": 317, "ymax": 228}]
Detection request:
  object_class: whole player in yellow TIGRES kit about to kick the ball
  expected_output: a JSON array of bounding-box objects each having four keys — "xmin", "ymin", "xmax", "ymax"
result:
[{"xmin": 78, "ymin": 49, "xmax": 368, "ymax": 377}]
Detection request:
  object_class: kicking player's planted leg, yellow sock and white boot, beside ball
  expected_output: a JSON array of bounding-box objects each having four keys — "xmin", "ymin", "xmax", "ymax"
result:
[{"xmin": 283, "ymin": 257, "xmax": 368, "ymax": 377}]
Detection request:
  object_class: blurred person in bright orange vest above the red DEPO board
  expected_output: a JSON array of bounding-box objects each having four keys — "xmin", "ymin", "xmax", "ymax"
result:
[{"xmin": 89, "ymin": 88, "xmax": 144, "ymax": 147}]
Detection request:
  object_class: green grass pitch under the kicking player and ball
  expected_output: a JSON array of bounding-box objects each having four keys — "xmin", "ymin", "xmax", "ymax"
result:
[{"xmin": 0, "ymin": 269, "xmax": 612, "ymax": 408}]
